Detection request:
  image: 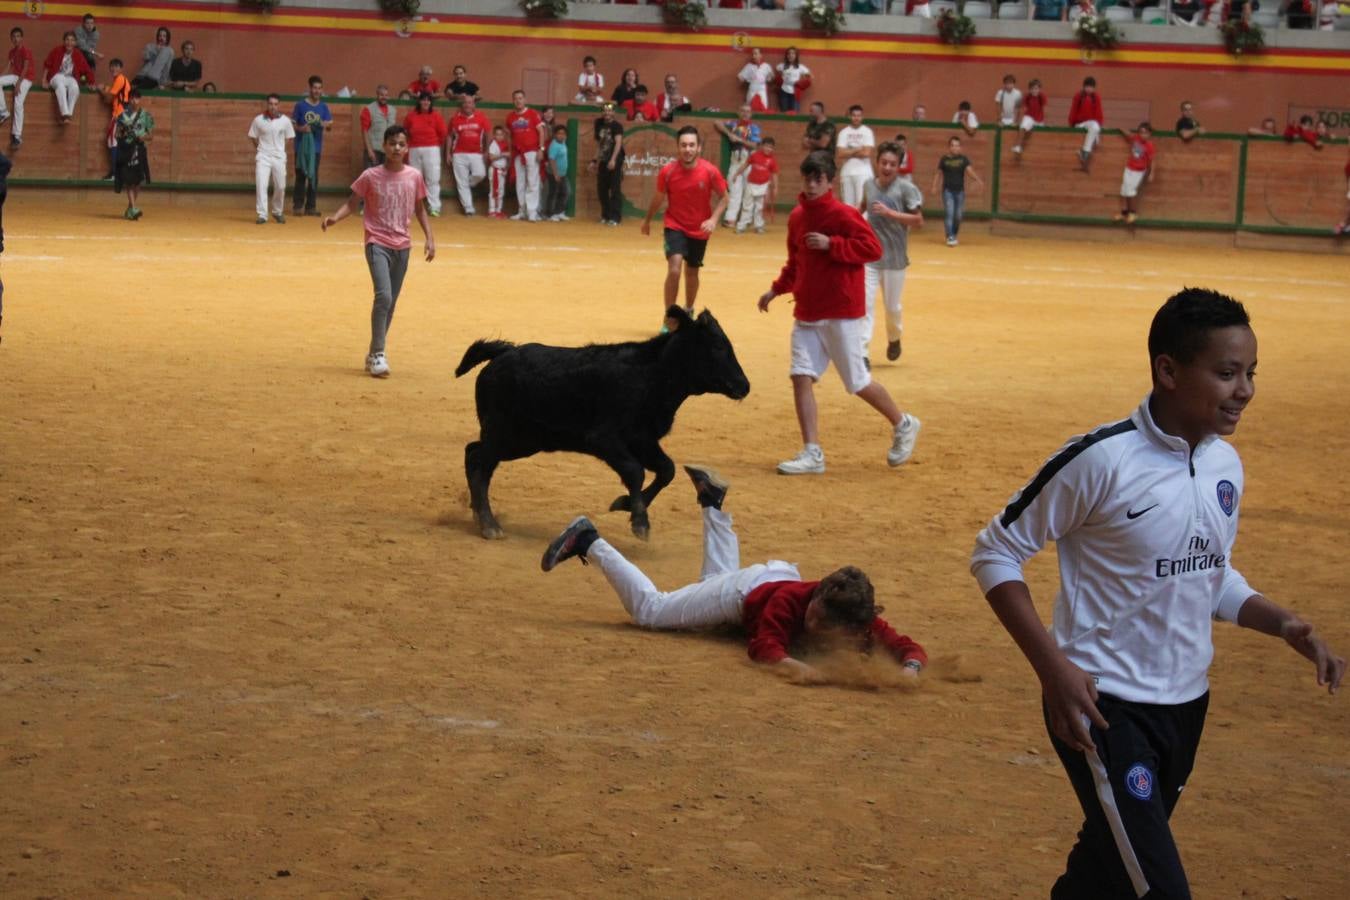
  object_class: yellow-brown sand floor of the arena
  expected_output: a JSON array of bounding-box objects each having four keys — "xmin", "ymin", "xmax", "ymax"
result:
[{"xmin": 0, "ymin": 192, "xmax": 1350, "ymax": 900}]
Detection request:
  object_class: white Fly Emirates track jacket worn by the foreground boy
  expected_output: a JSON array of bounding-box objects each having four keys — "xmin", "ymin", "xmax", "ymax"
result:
[{"xmin": 971, "ymin": 398, "xmax": 1256, "ymax": 704}]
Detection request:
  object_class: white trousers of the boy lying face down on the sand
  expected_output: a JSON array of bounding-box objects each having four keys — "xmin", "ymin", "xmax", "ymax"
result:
[{"xmin": 586, "ymin": 507, "xmax": 802, "ymax": 629}]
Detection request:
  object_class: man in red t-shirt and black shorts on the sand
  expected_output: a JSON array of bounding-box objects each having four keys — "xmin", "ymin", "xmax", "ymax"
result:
[{"xmin": 643, "ymin": 125, "xmax": 726, "ymax": 319}]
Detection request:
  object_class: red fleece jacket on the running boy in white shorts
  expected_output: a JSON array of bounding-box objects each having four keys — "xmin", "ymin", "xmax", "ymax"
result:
[{"xmin": 774, "ymin": 192, "xmax": 882, "ymax": 322}]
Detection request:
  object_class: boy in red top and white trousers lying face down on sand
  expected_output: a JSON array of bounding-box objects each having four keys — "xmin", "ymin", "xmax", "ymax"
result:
[{"xmin": 541, "ymin": 466, "xmax": 927, "ymax": 684}]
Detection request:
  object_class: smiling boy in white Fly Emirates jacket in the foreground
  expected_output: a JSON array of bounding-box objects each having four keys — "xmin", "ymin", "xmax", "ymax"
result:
[{"xmin": 971, "ymin": 289, "xmax": 1346, "ymax": 900}]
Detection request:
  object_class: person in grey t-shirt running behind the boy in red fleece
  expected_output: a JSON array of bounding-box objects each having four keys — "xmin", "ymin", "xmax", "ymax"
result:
[{"xmin": 863, "ymin": 142, "xmax": 923, "ymax": 363}]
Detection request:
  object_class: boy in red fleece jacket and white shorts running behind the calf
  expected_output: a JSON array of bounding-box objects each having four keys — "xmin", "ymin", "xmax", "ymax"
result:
[{"xmin": 759, "ymin": 150, "xmax": 919, "ymax": 475}]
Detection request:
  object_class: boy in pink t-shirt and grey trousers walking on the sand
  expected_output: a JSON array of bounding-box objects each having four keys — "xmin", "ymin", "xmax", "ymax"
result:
[{"xmin": 323, "ymin": 125, "xmax": 436, "ymax": 378}]
